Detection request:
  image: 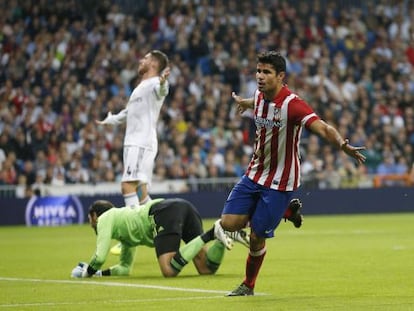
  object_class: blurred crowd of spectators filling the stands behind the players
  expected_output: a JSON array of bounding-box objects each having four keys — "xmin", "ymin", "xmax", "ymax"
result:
[{"xmin": 0, "ymin": 0, "xmax": 414, "ymax": 196}]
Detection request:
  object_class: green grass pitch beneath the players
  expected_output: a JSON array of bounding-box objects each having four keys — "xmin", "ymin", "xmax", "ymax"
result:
[{"xmin": 0, "ymin": 214, "xmax": 414, "ymax": 311}]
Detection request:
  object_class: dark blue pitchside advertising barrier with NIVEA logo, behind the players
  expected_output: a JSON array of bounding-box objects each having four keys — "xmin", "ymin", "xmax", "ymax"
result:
[{"xmin": 0, "ymin": 184, "xmax": 414, "ymax": 226}]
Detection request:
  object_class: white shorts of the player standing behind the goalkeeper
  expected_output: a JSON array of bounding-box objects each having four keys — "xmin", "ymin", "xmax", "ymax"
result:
[{"xmin": 121, "ymin": 146, "xmax": 157, "ymax": 185}]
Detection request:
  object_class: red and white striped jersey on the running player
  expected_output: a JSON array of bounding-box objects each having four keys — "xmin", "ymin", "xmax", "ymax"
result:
[{"xmin": 246, "ymin": 86, "xmax": 319, "ymax": 191}]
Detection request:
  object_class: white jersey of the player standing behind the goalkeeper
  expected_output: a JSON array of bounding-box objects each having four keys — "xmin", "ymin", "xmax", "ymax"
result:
[{"xmin": 124, "ymin": 76, "xmax": 168, "ymax": 151}]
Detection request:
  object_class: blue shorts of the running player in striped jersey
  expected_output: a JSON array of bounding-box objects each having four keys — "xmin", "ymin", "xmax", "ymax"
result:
[{"xmin": 222, "ymin": 176, "xmax": 293, "ymax": 238}]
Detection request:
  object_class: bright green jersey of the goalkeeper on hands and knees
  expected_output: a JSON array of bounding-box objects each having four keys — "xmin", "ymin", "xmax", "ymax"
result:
[{"xmin": 89, "ymin": 199, "xmax": 163, "ymax": 275}]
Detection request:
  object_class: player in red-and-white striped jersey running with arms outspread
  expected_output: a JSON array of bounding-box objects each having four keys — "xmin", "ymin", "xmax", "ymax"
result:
[{"xmin": 221, "ymin": 51, "xmax": 365, "ymax": 296}]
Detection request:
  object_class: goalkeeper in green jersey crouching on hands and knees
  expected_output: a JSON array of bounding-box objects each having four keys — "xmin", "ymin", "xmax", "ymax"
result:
[{"xmin": 71, "ymin": 198, "xmax": 249, "ymax": 277}]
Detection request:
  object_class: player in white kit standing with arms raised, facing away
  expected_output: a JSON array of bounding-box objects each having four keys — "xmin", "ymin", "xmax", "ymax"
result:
[{"xmin": 97, "ymin": 50, "xmax": 170, "ymax": 206}]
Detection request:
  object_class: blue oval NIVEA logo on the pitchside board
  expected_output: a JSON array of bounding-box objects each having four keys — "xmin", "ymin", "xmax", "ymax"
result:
[{"xmin": 25, "ymin": 196, "xmax": 85, "ymax": 226}]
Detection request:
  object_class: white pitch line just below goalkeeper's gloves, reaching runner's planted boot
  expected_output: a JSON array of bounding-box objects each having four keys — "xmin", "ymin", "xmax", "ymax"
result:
[{"xmin": 0, "ymin": 277, "xmax": 227, "ymax": 294}]
